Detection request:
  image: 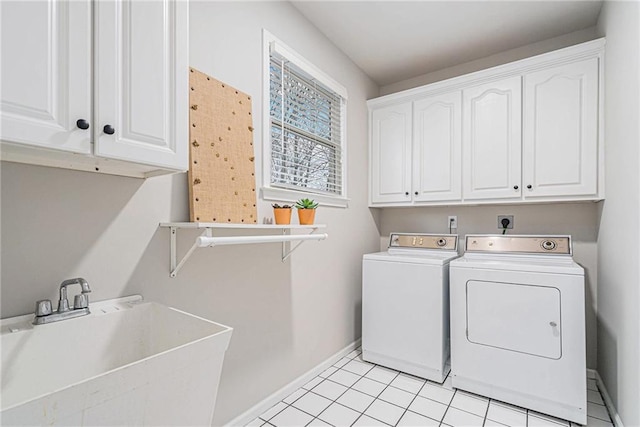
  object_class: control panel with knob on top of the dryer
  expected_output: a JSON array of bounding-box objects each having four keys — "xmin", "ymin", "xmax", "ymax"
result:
[{"xmin": 466, "ymin": 235, "xmax": 571, "ymax": 255}]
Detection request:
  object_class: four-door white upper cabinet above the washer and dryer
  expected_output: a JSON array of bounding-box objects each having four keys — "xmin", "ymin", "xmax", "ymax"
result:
[{"xmin": 368, "ymin": 39, "xmax": 604, "ymax": 206}]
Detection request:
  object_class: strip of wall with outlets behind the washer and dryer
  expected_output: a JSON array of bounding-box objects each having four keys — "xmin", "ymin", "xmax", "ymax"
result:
[{"xmin": 380, "ymin": 202, "xmax": 599, "ymax": 369}]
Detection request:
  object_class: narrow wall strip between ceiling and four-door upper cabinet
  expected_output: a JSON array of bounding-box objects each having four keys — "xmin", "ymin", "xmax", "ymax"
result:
[{"xmin": 380, "ymin": 27, "xmax": 598, "ymax": 95}]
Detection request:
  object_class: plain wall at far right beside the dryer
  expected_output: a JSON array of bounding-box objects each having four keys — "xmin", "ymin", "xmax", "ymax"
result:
[{"xmin": 598, "ymin": 0, "xmax": 640, "ymax": 426}]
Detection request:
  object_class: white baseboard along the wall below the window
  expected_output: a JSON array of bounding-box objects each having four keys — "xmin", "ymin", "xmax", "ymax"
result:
[{"xmin": 225, "ymin": 339, "xmax": 361, "ymax": 427}]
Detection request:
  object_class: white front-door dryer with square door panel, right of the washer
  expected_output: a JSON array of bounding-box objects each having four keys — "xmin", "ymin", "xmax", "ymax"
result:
[{"xmin": 450, "ymin": 235, "xmax": 587, "ymax": 424}]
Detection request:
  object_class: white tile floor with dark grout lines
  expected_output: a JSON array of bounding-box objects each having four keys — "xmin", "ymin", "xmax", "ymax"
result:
[{"xmin": 247, "ymin": 349, "xmax": 613, "ymax": 427}]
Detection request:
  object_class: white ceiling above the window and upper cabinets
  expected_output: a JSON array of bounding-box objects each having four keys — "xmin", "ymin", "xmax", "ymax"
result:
[{"xmin": 292, "ymin": 0, "xmax": 602, "ymax": 86}]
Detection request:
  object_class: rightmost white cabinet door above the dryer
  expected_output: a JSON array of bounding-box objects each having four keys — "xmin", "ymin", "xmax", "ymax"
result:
[{"xmin": 522, "ymin": 58, "xmax": 598, "ymax": 198}]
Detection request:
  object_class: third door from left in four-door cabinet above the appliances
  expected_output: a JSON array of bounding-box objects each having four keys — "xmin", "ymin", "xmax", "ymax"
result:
[{"xmin": 462, "ymin": 76, "xmax": 522, "ymax": 200}]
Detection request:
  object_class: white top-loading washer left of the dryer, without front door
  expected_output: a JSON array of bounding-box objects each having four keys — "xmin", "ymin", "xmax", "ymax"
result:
[{"xmin": 362, "ymin": 233, "xmax": 458, "ymax": 382}]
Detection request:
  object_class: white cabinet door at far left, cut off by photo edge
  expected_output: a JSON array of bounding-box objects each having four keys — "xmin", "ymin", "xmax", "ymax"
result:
[{"xmin": 0, "ymin": 0, "xmax": 93, "ymax": 154}]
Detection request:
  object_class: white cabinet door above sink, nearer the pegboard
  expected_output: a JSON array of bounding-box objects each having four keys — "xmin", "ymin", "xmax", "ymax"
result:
[{"xmin": 94, "ymin": 0, "xmax": 189, "ymax": 170}]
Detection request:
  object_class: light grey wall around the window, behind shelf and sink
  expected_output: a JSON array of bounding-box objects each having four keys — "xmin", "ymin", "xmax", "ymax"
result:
[{"xmin": 1, "ymin": 1, "xmax": 379, "ymax": 425}]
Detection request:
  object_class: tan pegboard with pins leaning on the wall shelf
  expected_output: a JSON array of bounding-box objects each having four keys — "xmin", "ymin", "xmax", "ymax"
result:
[{"xmin": 189, "ymin": 68, "xmax": 257, "ymax": 224}]
